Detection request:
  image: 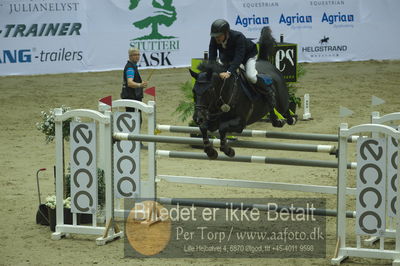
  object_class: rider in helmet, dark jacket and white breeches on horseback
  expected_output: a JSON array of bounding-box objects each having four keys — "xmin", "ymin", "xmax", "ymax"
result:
[{"xmin": 208, "ymin": 19, "xmax": 276, "ymax": 108}]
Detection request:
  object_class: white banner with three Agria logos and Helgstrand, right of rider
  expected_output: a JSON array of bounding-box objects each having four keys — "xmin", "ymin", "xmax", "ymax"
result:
[{"xmin": 227, "ymin": 0, "xmax": 400, "ymax": 62}]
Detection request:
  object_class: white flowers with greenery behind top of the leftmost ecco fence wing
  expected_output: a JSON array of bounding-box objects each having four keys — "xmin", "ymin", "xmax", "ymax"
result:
[{"xmin": 36, "ymin": 105, "xmax": 71, "ymax": 144}]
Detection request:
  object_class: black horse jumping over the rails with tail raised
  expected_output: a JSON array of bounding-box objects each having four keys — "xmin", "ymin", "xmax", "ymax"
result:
[{"xmin": 189, "ymin": 27, "xmax": 296, "ymax": 159}]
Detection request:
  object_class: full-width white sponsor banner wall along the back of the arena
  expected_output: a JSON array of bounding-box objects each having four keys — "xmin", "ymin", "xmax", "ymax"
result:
[{"xmin": 0, "ymin": 0, "xmax": 400, "ymax": 75}]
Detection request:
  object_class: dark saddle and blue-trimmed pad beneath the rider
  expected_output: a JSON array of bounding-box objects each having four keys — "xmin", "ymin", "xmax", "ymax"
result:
[{"xmin": 238, "ymin": 68, "xmax": 272, "ymax": 102}]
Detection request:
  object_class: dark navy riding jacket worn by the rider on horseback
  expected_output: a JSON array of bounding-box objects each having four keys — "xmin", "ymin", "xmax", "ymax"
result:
[{"xmin": 208, "ymin": 30, "xmax": 257, "ymax": 73}]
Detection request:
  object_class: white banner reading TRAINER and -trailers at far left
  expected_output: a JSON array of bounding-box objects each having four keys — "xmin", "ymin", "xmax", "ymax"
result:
[{"xmin": 0, "ymin": 0, "xmax": 89, "ymax": 75}]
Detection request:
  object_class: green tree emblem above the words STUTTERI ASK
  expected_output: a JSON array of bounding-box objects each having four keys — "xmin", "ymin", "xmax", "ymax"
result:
[{"xmin": 129, "ymin": 0, "xmax": 176, "ymax": 40}]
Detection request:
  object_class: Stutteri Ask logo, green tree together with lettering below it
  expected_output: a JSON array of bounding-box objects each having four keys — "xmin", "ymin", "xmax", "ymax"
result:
[{"xmin": 129, "ymin": 0, "xmax": 180, "ymax": 66}]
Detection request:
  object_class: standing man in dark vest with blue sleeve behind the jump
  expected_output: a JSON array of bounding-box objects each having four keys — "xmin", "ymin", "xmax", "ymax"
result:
[{"xmin": 121, "ymin": 47, "xmax": 147, "ymax": 112}]
